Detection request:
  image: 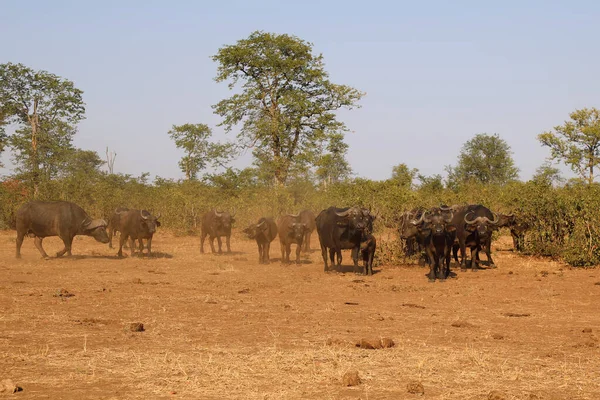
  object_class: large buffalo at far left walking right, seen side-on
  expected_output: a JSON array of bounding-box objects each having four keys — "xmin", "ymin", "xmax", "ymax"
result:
[{"xmin": 17, "ymin": 201, "xmax": 108, "ymax": 259}]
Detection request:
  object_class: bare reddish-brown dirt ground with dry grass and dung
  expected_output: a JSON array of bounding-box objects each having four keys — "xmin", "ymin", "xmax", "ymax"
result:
[{"xmin": 0, "ymin": 231, "xmax": 600, "ymax": 400}]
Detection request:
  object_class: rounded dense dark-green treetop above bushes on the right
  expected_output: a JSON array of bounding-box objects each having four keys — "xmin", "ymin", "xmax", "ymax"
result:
[{"xmin": 446, "ymin": 133, "xmax": 519, "ymax": 187}]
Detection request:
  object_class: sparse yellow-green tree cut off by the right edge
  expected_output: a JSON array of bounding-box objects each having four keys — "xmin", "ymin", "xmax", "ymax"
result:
[{"xmin": 538, "ymin": 108, "xmax": 600, "ymax": 184}]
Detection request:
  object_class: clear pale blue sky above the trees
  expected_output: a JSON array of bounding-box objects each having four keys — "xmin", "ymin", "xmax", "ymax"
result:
[{"xmin": 0, "ymin": 0, "xmax": 600, "ymax": 179}]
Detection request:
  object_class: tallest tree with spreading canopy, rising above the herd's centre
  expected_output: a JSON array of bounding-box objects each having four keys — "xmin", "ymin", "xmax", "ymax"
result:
[{"xmin": 213, "ymin": 31, "xmax": 363, "ymax": 185}]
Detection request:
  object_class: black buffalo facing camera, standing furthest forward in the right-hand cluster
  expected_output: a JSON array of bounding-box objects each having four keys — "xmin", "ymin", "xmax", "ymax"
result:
[{"xmin": 411, "ymin": 208, "xmax": 456, "ymax": 282}]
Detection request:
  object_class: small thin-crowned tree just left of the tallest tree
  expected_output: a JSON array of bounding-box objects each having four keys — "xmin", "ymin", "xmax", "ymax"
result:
[{"xmin": 168, "ymin": 124, "xmax": 232, "ymax": 180}]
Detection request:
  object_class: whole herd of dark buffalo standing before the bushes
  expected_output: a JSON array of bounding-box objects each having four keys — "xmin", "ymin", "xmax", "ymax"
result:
[{"xmin": 16, "ymin": 201, "xmax": 528, "ymax": 281}]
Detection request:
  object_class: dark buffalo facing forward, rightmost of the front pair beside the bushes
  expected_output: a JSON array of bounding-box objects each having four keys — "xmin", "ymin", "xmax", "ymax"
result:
[{"xmin": 451, "ymin": 204, "xmax": 499, "ymax": 271}]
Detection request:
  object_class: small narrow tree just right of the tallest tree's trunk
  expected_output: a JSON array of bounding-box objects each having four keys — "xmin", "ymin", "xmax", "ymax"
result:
[{"xmin": 316, "ymin": 133, "xmax": 352, "ymax": 186}]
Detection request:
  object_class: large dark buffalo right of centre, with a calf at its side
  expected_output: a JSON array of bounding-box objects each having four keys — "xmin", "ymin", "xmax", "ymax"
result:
[{"xmin": 316, "ymin": 207, "xmax": 375, "ymax": 272}]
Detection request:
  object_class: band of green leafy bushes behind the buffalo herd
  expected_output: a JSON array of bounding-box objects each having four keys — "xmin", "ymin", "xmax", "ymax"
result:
[{"xmin": 0, "ymin": 174, "xmax": 600, "ymax": 266}]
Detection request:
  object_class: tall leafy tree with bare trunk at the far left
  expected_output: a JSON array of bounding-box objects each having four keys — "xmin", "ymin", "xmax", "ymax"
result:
[{"xmin": 0, "ymin": 63, "xmax": 85, "ymax": 197}]
